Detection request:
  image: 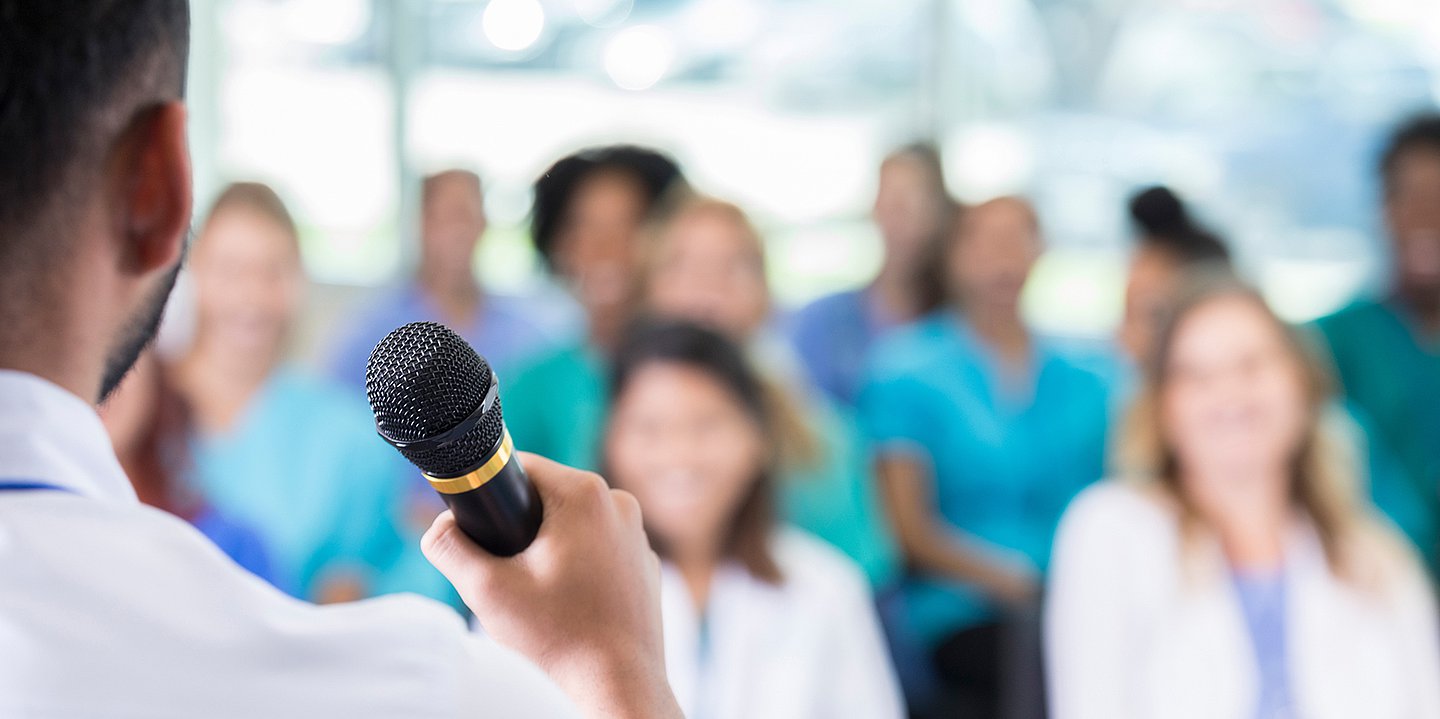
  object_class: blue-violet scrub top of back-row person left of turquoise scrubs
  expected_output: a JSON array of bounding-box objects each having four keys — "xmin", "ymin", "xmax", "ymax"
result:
[{"xmin": 788, "ymin": 290, "xmax": 899, "ymax": 406}]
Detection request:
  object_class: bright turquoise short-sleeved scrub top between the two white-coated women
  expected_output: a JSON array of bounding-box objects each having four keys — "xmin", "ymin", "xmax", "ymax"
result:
[{"xmin": 860, "ymin": 313, "xmax": 1109, "ymax": 643}]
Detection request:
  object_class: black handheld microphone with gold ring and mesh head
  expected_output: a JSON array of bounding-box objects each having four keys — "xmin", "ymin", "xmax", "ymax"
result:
[{"xmin": 364, "ymin": 323, "xmax": 543, "ymax": 556}]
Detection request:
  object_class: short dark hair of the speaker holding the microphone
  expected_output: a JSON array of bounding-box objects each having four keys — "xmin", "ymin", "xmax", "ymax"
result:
[{"xmin": 0, "ymin": 0, "xmax": 190, "ymax": 247}]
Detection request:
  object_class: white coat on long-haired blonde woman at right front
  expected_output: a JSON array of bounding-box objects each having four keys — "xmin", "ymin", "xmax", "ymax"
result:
[{"xmin": 1045, "ymin": 481, "xmax": 1440, "ymax": 719}]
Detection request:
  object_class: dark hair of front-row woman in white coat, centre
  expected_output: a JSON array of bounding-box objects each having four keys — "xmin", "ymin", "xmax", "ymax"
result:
[{"xmin": 605, "ymin": 321, "xmax": 783, "ymax": 584}]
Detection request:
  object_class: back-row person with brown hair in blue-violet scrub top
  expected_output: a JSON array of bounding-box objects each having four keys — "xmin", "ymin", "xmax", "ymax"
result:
[{"xmin": 791, "ymin": 143, "xmax": 958, "ymax": 406}]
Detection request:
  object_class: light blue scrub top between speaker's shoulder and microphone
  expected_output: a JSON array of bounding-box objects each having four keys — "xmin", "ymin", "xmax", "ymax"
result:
[{"xmin": 193, "ymin": 369, "xmax": 452, "ymax": 601}]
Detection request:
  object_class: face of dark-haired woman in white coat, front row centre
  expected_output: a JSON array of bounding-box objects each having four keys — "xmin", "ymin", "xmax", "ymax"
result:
[{"xmin": 605, "ymin": 362, "xmax": 765, "ymax": 553}]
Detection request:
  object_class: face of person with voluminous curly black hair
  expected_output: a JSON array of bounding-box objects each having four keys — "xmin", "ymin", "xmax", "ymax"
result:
[{"xmin": 554, "ymin": 173, "xmax": 645, "ymax": 314}]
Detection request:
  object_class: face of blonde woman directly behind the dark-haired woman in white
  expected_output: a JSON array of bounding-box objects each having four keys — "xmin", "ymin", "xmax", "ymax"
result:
[{"xmin": 647, "ymin": 212, "xmax": 770, "ymax": 341}]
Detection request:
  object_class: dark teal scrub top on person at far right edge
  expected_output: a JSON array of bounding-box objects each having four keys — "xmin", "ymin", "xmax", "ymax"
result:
[{"xmin": 1316, "ymin": 301, "xmax": 1440, "ymax": 571}]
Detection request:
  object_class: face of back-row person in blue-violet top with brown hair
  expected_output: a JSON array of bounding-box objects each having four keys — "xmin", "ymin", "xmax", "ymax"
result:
[{"xmin": 871, "ymin": 156, "xmax": 945, "ymax": 267}]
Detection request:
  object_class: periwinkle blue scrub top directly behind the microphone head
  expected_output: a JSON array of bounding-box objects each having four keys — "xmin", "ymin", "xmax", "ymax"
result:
[{"xmin": 328, "ymin": 284, "xmax": 554, "ymax": 388}]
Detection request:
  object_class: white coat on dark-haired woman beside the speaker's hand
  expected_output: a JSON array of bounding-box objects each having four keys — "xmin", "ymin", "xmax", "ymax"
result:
[{"xmin": 661, "ymin": 529, "xmax": 904, "ymax": 719}]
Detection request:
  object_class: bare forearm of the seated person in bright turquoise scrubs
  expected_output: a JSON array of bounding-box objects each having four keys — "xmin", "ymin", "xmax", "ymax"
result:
[{"xmin": 876, "ymin": 452, "xmax": 1040, "ymax": 604}]
